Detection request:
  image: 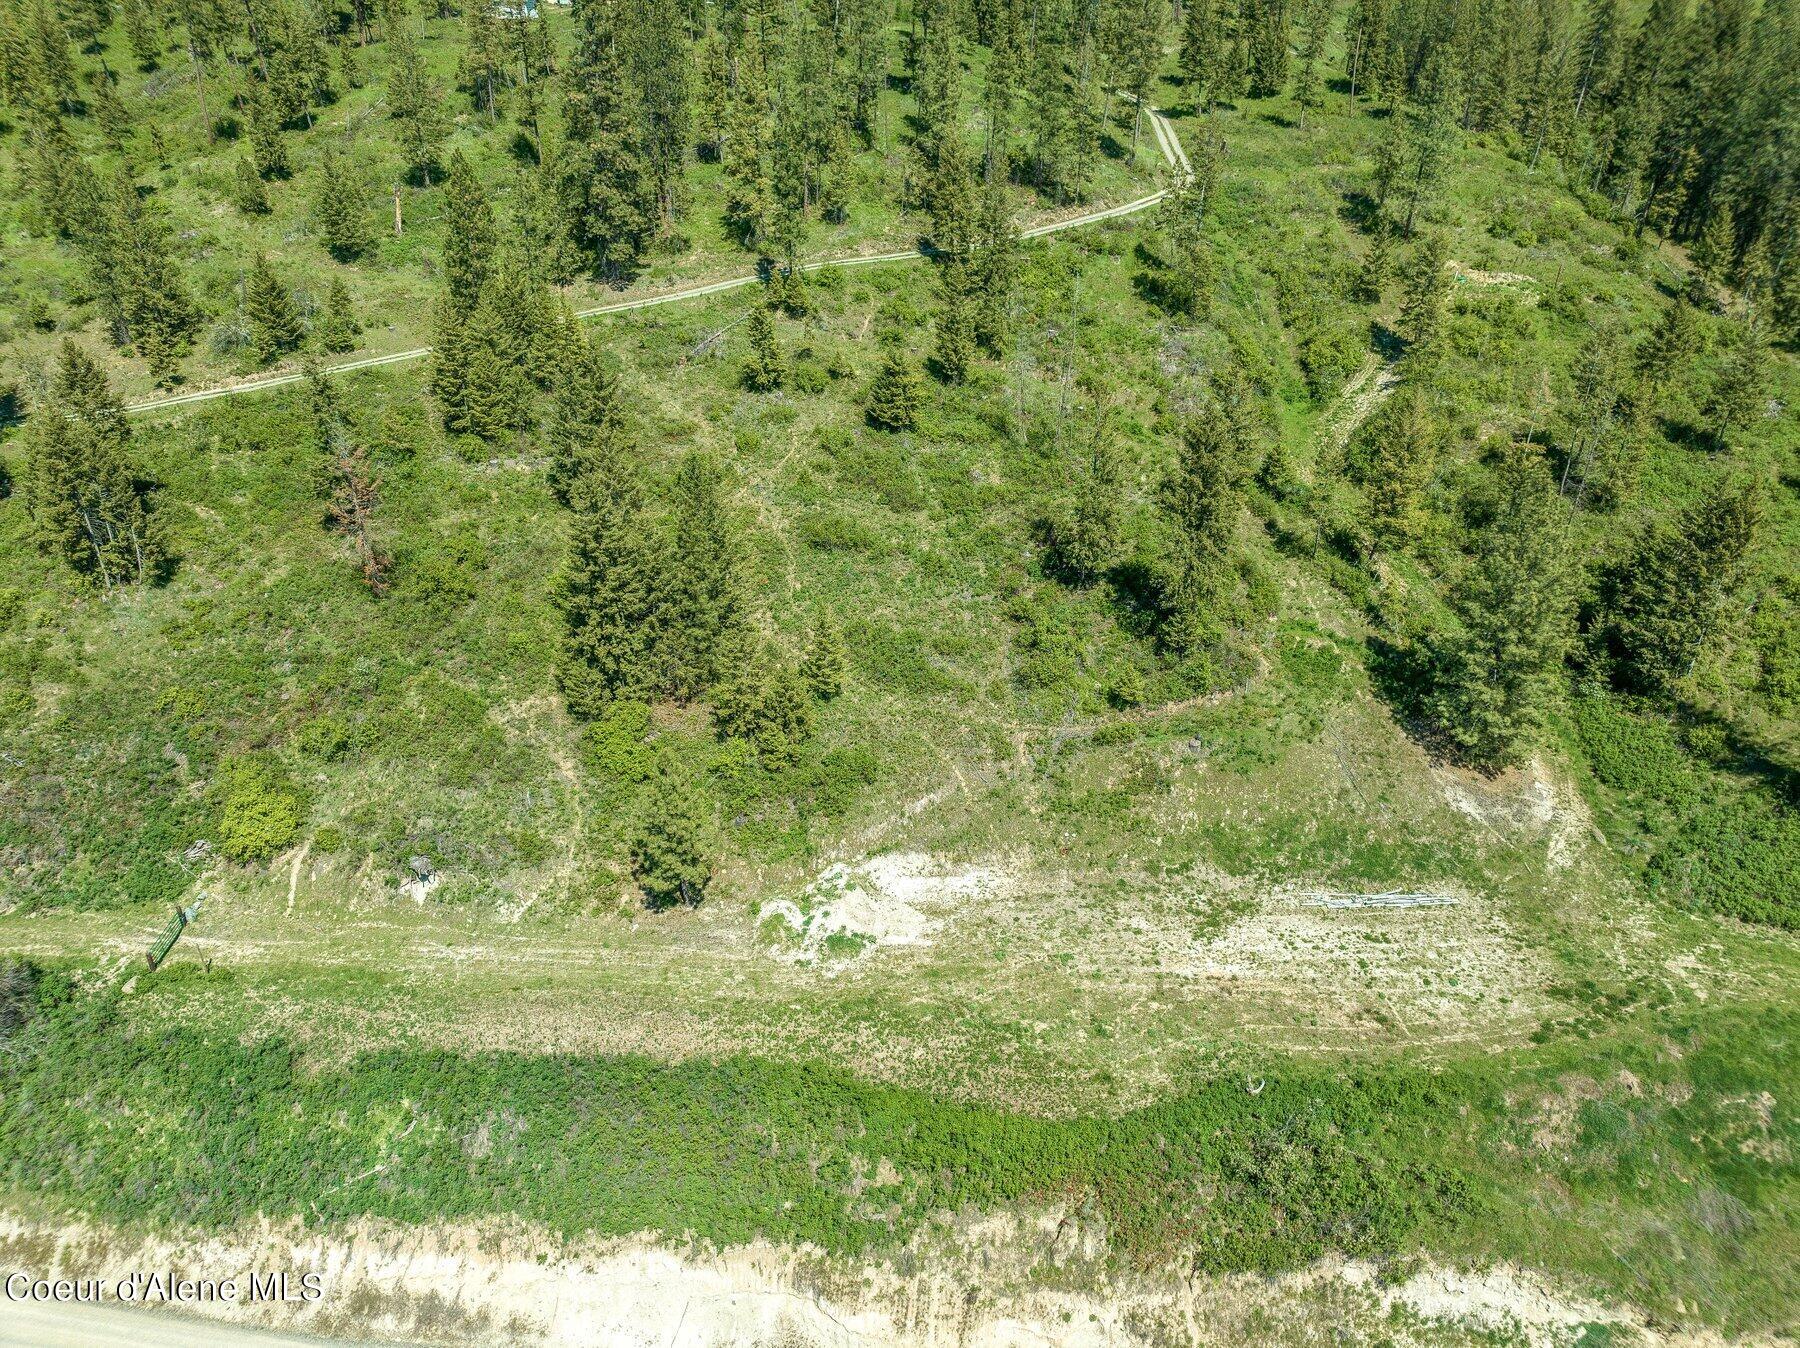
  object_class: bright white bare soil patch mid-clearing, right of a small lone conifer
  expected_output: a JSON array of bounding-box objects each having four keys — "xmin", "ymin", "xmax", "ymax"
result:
[{"xmin": 756, "ymin": 851, "xmax": 1010, "ymax": 970}]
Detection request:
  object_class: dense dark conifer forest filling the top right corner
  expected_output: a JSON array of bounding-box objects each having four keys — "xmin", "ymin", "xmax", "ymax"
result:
[{"xmin": 1179, "ymin": 0, "xmax": 1800, "ymax": 340}]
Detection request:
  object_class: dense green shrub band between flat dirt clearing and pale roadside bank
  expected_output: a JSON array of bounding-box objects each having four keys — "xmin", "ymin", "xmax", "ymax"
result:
[{"xmin": 0, "ymin": 1002, "xmax": 1469, "ymax": 1269}]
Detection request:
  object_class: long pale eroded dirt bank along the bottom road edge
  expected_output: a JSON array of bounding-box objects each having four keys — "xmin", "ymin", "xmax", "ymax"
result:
[{"xmin": 0, "ymin": 1209, "xmax": 1755, "ymax": 1348}]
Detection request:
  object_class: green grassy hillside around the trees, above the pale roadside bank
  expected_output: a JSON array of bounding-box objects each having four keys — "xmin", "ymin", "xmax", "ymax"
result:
[{"xmin": 0, "ymin": 2, "xmax": 1800, "ymax": 1334}]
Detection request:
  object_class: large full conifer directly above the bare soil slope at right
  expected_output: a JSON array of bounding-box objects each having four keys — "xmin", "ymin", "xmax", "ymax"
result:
[{"xmin": 1427, "ymin": 446, "xmax": 1575, "ymax": 768}]
